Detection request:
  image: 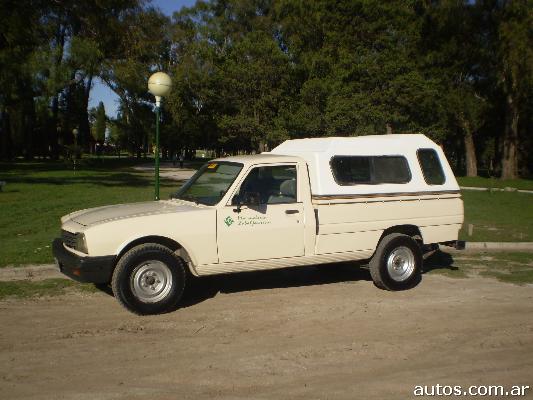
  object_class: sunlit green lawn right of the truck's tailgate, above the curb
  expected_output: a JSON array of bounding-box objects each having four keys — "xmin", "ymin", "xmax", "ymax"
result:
[{"xmin": 459, "ymin": 190, "xmax": 533, "ymax": 242}]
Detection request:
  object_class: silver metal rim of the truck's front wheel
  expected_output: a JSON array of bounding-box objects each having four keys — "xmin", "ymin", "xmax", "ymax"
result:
[{"xmin": 131, "ymin": 260, "xmax": 173, "ymax": 303}]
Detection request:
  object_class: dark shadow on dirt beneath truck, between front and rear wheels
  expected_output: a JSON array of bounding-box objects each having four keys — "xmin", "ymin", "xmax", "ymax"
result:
[{"xmin": 181, "ymin": 262, "xmax": 372, "ymax": 308}]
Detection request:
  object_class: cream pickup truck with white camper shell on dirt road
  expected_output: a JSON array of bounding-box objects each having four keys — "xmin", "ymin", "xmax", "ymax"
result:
[{"xmin": 53, "ymin": 135, "xmax": 463, "ymax": 314}]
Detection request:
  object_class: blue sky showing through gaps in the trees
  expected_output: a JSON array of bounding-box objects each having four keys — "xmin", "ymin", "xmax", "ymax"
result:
[{"xmin": 89, "ymin": 0, "xmax": 196, "ymax": 117}]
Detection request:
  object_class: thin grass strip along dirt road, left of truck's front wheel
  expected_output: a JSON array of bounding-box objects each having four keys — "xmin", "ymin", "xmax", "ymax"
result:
[{"xmin": 0, "ymin": 278, "xmax": 99, "ymax": 300}]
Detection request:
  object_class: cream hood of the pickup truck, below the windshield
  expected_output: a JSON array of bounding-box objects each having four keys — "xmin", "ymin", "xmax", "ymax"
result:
[{"xmin": 64, "ymin": 201, "xmax": 200, "ymax": 226}]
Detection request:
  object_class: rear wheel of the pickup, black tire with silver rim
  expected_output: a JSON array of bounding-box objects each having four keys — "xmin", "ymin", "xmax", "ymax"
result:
[{"xmin": 369, "ymin": 233, "xmax": 423, "ymax": 290}]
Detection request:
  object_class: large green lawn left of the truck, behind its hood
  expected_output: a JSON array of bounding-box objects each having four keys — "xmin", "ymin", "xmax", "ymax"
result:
[{"xmin": 0, "ymin": 159, "xmax": 186, "ymax": 266}]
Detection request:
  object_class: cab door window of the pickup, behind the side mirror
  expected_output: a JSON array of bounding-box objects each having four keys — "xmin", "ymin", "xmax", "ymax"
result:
[{"xmin": 232, "ymin": 165, "xmax": 297, "ymax": 204}]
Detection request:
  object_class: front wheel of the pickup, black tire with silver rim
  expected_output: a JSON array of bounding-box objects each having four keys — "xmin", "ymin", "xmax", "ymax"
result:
[{"xmin": 111, "ymin": 243, "xmax": 186, "ymax": 315}]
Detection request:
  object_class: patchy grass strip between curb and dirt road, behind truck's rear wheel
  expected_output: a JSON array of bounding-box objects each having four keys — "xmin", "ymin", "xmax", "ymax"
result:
[{"xmin": 424, "ymin": 252, "xmax": 533, "ymax": 285}]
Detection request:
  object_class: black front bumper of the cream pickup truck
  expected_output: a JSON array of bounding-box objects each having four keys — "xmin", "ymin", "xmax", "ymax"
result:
[{"xmin": 52, "ymin": 239, "xmax": 115, "ymax": 283}]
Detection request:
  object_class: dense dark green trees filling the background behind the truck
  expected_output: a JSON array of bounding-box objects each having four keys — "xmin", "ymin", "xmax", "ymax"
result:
[{"xmin": 0, "ymin": 0, "xmax": 533, "ymax": 178}]
